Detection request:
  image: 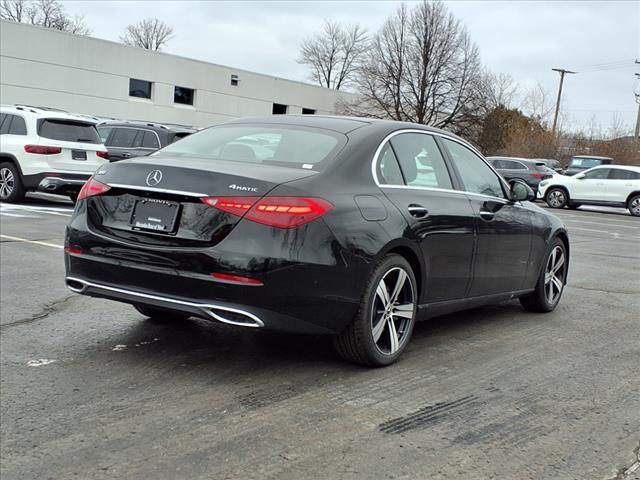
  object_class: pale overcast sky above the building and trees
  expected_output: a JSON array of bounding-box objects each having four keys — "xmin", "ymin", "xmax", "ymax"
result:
[{"xmin": 65, "ymin": 0, "xmax": 640, "ymax": 133}]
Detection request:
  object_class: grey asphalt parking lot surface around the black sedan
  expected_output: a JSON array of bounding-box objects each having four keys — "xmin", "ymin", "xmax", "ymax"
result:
[{"xmin": 0, "ymin": 193, "xmax": 640, "ymax": 480}]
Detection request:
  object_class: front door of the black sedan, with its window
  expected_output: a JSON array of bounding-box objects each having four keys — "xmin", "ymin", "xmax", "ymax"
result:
[{"xmin": 443, "ymin": 138, "xmax": 533, "ymax": 297}]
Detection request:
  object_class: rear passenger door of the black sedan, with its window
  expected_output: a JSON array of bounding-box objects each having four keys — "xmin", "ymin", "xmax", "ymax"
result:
[{"xmin": 378, "ymin": 132, "xmax": 474, "ymax": 303}]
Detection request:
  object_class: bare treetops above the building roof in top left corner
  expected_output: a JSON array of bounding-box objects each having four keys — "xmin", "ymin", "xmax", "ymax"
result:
[{"xmin": 0, "ymin": 0, "xmax": 91, "ymax": 35}]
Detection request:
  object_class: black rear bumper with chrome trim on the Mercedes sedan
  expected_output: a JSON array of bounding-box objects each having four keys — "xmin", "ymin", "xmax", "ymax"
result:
[{"xmin": 65, "ymin": 212, "xmax": 364, "ymax": 334}]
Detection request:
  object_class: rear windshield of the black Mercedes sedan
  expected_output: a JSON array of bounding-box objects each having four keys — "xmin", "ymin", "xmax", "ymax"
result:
[{"xmin": 160, "ymin": 125, "xmax": 346, "ymax": 171}]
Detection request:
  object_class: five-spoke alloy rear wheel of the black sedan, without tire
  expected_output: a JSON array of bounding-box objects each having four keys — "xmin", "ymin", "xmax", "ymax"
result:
[{"xmin": 371, "ymin": 267, "xmax": 415, "ymax": 355}]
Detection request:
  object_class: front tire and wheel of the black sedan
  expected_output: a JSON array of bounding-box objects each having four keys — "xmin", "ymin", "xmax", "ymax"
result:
[{"xmin": 520, "ymin": 238, "xmax": 568, "ymax": 313}]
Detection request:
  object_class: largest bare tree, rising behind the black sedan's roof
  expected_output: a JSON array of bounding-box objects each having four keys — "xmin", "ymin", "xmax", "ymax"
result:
[{"xmin": 346, "ymin": 0, "xmax": 484, "ymax": 135}]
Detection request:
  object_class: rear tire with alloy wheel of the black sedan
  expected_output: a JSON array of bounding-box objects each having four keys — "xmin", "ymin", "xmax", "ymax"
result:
[{"xmin": 334, "ymin": 254, "xmax": 418, "ymax": 367}]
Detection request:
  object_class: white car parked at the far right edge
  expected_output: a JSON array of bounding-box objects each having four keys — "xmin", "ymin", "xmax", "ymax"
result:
[{"xmin": 538, "ymin": 165, "xmax": 640, "ymax": 217}]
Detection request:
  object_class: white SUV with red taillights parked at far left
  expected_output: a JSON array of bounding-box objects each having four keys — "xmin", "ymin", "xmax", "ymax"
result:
[{"xmin": 0, "ymin": 105, "xmax": 109, "ymax": 202}]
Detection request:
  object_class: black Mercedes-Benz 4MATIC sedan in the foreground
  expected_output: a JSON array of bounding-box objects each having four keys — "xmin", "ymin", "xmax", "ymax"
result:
[{"xmin": 65, "ymin": 115, "xmax": 569, "ymax": 366}]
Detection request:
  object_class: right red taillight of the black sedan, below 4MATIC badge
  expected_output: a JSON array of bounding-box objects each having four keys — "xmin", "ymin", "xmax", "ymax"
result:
[{"xmin": 202, "ymin": 197, "xmax": 333, "ymax": 228}]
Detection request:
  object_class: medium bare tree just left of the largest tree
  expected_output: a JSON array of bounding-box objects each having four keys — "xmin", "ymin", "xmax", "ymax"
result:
[{"xmin": 298, "ymin": 20, "xmax": 367, "ymax": 90}]
